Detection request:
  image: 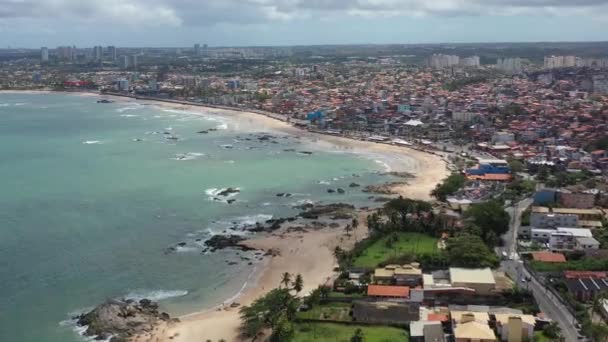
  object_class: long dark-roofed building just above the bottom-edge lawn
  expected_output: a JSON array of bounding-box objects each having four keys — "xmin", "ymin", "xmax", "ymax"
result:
[{"xmin": 353, "ymin": 301, "xmax": 420, "ymax": 326}]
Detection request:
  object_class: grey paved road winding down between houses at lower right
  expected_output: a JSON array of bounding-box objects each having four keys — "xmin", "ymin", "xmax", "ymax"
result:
[{"xmin": 496, "ymin": 199, "xmax": 579, "ymax": 341}]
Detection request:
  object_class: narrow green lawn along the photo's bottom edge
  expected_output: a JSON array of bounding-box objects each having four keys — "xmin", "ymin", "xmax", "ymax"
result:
[{"xmin": 294, "ymin": 323, "xmax": 409, "ymax": 342}]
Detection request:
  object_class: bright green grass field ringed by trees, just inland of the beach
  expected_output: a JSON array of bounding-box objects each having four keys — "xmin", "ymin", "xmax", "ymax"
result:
[{"xmin": 353, "ymin": 233, "xmax": 439, "ymax": 268}]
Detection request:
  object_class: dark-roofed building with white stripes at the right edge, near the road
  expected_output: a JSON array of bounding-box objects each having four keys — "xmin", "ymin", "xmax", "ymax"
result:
[{"xmin": 564, "ymin": 271, "xmax": 608, "ymax": 302}]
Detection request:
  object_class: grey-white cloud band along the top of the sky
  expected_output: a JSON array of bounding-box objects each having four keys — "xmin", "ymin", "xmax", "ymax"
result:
[{"xmin": 0, "ymin": 0, "xmax": 608, "ymax": 27}]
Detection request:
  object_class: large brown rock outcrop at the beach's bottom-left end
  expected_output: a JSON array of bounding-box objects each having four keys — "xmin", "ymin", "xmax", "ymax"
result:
[{"xmin": 77, "ymin": 299, "xmax": 179, "ymax": 342}]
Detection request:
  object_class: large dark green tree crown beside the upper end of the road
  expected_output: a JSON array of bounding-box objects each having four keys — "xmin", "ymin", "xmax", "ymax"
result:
[{"xmin": 464, "ymin": 201, "xmax": 511, "ymax": 246}]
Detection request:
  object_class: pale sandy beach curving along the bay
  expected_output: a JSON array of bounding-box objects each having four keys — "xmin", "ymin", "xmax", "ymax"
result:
[{"xmin": 0, "ymin": 90, "xmax": 449, "ymax": 342}]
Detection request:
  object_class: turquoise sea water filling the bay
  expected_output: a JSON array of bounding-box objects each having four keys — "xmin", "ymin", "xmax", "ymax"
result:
[{"xmin": 0, "ymin": 94, "xmax": 385, "ymax": 342}]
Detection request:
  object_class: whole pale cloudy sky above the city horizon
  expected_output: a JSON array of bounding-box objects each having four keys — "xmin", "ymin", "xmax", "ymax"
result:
[{"xmin": 0, "ymin": 0, "xmax": 608, "ymax": 48}]
